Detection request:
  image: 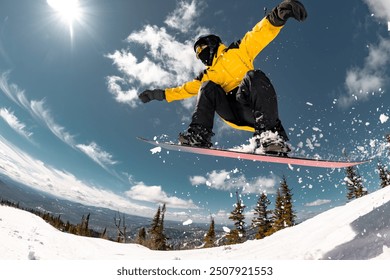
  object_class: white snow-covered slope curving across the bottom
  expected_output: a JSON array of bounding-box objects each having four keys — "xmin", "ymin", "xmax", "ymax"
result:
[{"xmin": 0, "ymin": 187, "xmax": 390, "ymax": 260}]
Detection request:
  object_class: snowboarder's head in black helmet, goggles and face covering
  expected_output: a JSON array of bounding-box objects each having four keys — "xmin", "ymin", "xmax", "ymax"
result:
[{"xmin": 194, "ymin": 34, "xmax": 222, "ymax": 66}]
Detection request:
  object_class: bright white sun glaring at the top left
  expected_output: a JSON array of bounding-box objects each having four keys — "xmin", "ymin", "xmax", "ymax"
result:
[{"xmin": 47, "ymin": 0, "xmax": 82, "ymax": 37}]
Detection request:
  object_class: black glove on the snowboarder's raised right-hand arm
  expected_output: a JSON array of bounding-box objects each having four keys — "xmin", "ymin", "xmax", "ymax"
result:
[{"xmin": 267, "ymin": 0, "xmax": 307, "ymax": 26}]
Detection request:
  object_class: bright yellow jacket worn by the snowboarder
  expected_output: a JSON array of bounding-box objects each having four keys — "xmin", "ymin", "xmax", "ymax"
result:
[{"xmin": 165, "ymin": 18, "xmax": 282, "ymax": 131}]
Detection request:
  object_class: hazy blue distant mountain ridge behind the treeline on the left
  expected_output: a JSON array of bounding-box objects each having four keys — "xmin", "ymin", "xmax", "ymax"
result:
[{"xmin": 0, "ymin": 177, "xmax": 212, "ymax": 248}]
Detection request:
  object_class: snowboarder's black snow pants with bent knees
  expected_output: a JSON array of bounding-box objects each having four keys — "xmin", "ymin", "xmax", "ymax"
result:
[{"xmin": 190, "ymin": 70, "xmax": 288, "ymax": 141}]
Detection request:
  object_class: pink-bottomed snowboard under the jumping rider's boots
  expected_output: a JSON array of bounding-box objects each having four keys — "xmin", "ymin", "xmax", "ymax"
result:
[{"xmin": 137, "ymin": 137, "xmax": 368, "ymax": 168}]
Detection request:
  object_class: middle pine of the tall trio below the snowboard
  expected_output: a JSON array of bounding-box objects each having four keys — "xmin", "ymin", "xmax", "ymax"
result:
[{"xmin": 252, "ymin": 193, "xmax": 271, "ymax": 239}]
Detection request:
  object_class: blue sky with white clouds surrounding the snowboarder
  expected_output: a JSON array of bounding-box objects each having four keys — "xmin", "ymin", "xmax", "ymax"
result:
[{"xmin": 0, "ymin": 0, "xmax": 390, "ymax": 222}]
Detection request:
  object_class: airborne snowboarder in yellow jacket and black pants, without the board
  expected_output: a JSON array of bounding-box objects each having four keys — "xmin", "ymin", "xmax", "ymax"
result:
[{"xmin": 139, "ymin": 0, "xmax": 307, "ymax": 154}]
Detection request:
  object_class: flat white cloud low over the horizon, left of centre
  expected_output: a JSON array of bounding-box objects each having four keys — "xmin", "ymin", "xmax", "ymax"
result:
[{"xmin": 126, "ymin": 182, "xmax": 197, "ymax": 209}]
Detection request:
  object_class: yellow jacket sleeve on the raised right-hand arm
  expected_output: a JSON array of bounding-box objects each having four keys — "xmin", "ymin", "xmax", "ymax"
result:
[{"xmin": 240, "ymin": 18, "xmax": 283, "ymax": 61}]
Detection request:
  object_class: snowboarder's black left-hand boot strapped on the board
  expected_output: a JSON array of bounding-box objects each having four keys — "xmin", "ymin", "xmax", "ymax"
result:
[{"xmin": 179, "ymin": 125, "xmax": 214, "ymax": 148}]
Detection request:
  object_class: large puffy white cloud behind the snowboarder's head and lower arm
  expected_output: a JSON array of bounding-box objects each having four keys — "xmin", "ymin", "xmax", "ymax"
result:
[{"xmin": 106, "ymin": 0, "xmax": 208, "ymax": 107}]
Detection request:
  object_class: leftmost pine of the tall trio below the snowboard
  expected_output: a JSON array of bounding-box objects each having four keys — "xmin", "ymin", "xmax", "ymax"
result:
[{"xmin": 226, "ymin": 192, "xmax": 246, "ymax": 244}]
